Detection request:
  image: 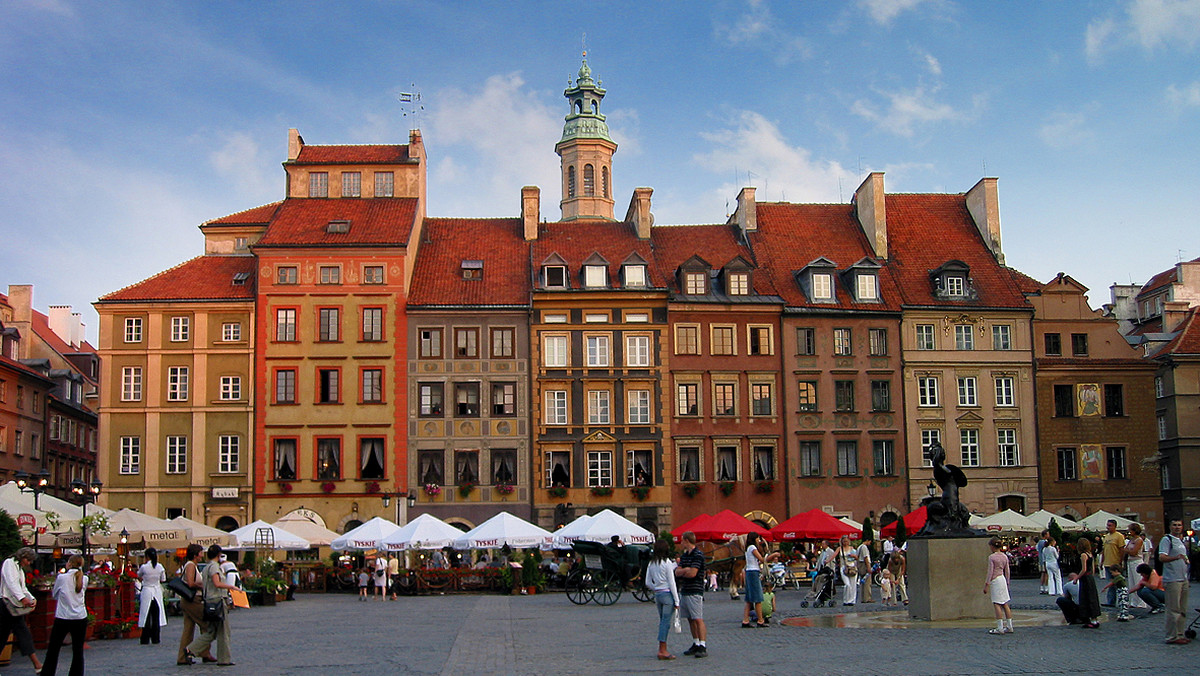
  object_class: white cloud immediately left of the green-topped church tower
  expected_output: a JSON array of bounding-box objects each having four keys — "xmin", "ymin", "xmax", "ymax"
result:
[{"xmin": 424, "ymin": 73, "xmax": 566, "ymax": 219}]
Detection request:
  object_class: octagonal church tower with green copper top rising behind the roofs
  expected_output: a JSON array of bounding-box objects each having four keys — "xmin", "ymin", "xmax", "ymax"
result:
[{"xmin": 554, "ymin": 53, "xmax": 617, "ymax": 221}]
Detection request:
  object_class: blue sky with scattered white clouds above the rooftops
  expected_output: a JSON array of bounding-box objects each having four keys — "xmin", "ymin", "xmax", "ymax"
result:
[{"xmin": 0, "ymin": 0, "xmax": 1200, "ymax": 341}]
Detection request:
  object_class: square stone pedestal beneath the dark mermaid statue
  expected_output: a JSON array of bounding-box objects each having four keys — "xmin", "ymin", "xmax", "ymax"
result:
[{"xmin": 907, "ymin": 538, "xmax": 996, "ymax": 620}]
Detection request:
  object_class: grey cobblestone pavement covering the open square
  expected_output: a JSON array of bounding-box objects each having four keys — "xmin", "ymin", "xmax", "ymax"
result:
[{"xmin": 42, "ymin": 580, "xmax": 1200, "ymax": 676}]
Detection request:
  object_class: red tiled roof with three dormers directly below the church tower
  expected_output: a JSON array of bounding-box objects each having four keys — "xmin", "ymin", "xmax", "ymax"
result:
[{"xmin": 532, "ymin": 220, "xmax": 666, "ymax": 289}]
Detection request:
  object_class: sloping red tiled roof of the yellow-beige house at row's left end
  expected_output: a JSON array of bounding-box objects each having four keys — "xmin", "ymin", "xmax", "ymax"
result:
[{"xmin": 98, "ymin": 256, "xmax": 257, "ymax": 303}]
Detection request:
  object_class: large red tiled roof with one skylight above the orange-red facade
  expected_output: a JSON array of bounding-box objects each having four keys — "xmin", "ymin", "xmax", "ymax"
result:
[{"xmin": 256, "ymin": 197, "xmax": 416, "ymax": 246}]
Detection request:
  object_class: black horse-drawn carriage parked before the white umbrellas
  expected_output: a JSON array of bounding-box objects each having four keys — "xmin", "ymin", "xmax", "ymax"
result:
[{"xmin": 566, "ymin": 540, "xmax": 654, "ymax": 605}]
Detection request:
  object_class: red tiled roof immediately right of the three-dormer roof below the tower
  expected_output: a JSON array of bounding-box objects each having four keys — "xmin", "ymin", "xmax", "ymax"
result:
[{"xmin": 650, "ymin": 225, "xmax": 778, "ymax": 295}]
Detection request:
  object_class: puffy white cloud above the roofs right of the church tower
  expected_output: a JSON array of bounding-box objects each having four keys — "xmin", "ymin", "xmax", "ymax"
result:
[{"xmin": 692, "ymin": 110, "xmax": 858, "ymax": 210}]
